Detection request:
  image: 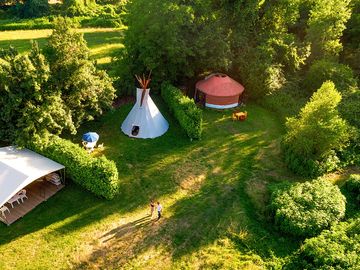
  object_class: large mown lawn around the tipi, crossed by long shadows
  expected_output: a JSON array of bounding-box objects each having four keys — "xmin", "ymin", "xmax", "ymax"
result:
[{"xmin": 0, "ymin": 98, "xmax": 299, "ymax": 269}]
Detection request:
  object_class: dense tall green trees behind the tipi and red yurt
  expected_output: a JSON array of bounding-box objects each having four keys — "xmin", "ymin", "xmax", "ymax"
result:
[{"xmin": 119, "ymin": 0, "xmax": 351, "ymax": 95}]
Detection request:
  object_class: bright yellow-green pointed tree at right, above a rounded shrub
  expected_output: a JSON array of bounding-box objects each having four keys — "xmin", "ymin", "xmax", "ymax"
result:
[{"xmin": 283, "ymin": 82, "xmax": 351, "ymax": 176}]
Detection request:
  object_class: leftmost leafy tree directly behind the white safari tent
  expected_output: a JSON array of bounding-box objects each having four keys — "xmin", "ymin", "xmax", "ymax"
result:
[{"xmin": 0, "ymin": 43, "xmax": 74, "ymax": 145}]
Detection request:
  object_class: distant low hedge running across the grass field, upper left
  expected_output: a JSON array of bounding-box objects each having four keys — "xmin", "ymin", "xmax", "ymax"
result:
[{"xmin": 0, "ymin": 17, "xmax": 122, "ymax": 31}]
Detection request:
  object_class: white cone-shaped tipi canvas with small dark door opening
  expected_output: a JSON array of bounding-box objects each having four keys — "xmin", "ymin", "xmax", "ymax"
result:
[{"xmin": 121, "ymin": 88, "xmax": 169, "ymax": 139}]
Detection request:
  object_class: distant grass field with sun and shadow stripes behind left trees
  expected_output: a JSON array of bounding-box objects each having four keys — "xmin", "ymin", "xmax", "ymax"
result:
[{"xmin": 0, "ymin": 28, "xmax": 123, "ymax": 66}]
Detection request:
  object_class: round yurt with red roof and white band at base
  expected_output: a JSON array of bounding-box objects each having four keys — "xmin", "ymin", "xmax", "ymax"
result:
[{"xmin": 195, "ymin": 73, "xmax": 245, "ymax": 109}]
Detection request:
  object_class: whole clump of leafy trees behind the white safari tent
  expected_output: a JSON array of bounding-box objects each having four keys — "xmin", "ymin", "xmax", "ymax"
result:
[{"xmin": 0, "ymin": 18, "xmax": 115, "ymax": 145}]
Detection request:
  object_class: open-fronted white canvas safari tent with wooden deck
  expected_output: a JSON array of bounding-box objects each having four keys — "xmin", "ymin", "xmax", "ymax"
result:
[{"xmin": 0, "ymin": 146, "xmax": 65, "ymax": 225}]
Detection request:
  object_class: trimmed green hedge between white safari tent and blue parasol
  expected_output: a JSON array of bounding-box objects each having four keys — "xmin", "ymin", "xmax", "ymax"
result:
[{"xmin": 28, "ymin": 136, "xmax": 119, "ymax": 199}]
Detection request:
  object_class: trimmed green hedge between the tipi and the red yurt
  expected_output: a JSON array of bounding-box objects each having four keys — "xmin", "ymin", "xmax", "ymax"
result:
[{"xmin": 161, "ymin": 83, "xmax": 203, "ymax": 139}]
